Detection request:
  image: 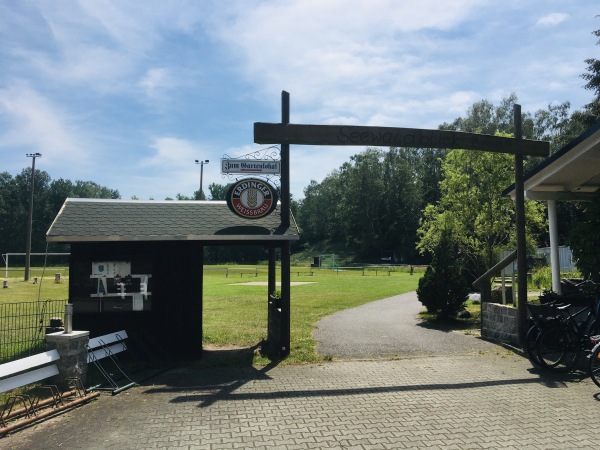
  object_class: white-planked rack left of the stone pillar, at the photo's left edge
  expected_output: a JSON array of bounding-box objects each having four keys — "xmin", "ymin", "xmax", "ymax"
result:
[{"xmin": 0, "ymin": 350, "xmax": 96, "ymax": 435}]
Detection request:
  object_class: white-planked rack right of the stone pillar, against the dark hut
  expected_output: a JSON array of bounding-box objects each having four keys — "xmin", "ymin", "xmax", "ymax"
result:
[{"xmin": 87, "ymin": 330, "xmax": 136, "ymax": 395}]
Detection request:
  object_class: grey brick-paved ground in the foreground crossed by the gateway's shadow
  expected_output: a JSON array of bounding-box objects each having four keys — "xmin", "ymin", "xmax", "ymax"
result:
[{"xmin": 0, "ymin": 294, "xmax": 600, "ymax": 450}]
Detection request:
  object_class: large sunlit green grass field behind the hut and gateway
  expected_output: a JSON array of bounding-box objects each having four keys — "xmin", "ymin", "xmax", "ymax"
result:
[{"xmin": 0, "ymin": 266, "xmax": 422, "ymax": 363}]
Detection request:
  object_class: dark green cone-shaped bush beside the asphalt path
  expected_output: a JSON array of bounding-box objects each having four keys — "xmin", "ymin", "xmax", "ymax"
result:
[{"xmin": 417, "ymin": 232, "xmax": 469, "ymax": 319}]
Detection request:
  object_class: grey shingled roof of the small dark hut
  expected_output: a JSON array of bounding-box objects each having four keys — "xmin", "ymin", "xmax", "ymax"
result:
[{"xmin": 46, "ymin": 198, "xmax": 299, "ymax": 242}]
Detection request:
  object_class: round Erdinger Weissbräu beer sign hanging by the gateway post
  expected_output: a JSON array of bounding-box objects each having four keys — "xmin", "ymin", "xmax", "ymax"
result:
[{"xmin": 227, "ymin": 178, "xmax": 277, "ymax": 219}]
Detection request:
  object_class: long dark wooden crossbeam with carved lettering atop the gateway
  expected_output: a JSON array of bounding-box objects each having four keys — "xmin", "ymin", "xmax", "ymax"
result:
[{"xmin": 254, "ymin": 122, "xmax": 550, "ymax": 156}]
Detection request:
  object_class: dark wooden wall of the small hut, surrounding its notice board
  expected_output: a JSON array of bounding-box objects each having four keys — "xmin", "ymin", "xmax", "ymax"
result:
[{"xmin": 69, "ymin": 241, "xmax": 203, "ymax": 358}]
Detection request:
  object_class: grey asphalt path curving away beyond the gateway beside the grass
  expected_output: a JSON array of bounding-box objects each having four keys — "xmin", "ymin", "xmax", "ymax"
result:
[{"xmin": 313, "ymin": 292, "xmax": 498, "ymax": 359}]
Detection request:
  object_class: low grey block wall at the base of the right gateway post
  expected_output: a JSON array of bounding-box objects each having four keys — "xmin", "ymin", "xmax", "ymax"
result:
[{"xmin": 481, "ymin": 302, "xmax": 519, "ymax": 345}]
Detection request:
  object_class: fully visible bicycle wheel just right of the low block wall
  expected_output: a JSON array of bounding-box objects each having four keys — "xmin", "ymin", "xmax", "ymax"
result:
[{"xmin": 536, "ymin": 325, "xmax": 580, "ymax": 372}]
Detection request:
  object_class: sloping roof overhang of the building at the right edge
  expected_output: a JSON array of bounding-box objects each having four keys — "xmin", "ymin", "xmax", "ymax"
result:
[{"xmin": 503, "ymin": 122, "xmax": 600, "ymax": 201}]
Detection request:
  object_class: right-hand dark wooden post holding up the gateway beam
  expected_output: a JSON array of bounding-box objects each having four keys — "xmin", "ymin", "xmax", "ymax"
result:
[{"xmin": 514, "ymin": 105, "xmax": 527, "ymax": 343}]
